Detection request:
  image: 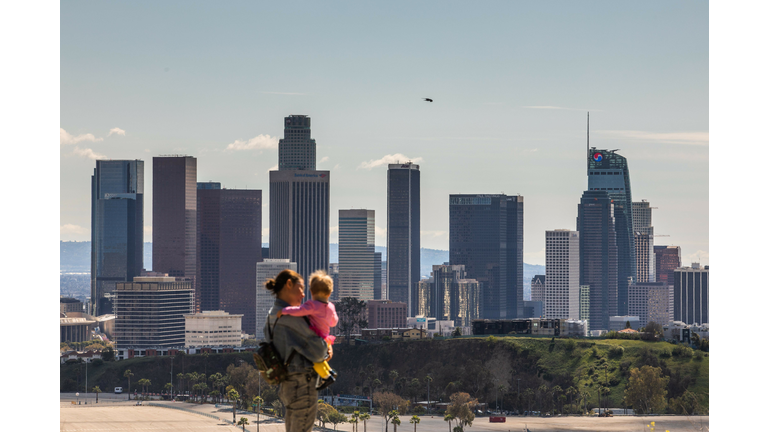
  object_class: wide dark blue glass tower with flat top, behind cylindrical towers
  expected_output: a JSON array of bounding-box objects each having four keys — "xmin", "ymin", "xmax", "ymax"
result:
[{"xmin": 449, "ymin": 194, "xmax": 523, "ymax": 319}]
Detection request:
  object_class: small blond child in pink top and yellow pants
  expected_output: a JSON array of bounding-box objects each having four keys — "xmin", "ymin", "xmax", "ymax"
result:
[{"xmin": 277, "ymin": 270, "xmax": 339, "ymax": 390}]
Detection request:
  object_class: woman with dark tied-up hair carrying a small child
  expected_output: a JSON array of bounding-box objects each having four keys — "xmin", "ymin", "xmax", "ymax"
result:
[{"xmin": 264, "ymin": 269, "xmax": 333, "ymax": 432}]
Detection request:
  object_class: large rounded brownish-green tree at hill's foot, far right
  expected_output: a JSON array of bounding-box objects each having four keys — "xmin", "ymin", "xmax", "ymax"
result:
[{"xmin": 624, "ymin": 365, "xmax": 669, "ymax": 414}]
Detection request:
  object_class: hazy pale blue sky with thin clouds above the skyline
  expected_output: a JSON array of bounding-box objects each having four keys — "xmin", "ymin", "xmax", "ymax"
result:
[{"xmin": 60, "ymin": 1, "xmax": 709, "ymax": 265}]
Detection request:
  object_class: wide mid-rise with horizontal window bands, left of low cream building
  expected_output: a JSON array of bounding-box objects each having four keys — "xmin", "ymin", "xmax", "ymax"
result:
[{"xmin": 115, "ymin": 276, "xmax": 195, "ymax": 349}]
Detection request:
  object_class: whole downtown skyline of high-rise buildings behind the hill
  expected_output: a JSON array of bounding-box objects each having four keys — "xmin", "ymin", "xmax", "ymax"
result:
[{"xmin": 73, "ymin": 115, "xmax": 709, "ymax": 355}]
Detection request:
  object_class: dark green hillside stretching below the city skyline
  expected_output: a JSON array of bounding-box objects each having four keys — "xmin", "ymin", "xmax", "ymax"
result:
[{"xmin": 60, "ymin": 337, "xmax": 709, "ymax": 411}]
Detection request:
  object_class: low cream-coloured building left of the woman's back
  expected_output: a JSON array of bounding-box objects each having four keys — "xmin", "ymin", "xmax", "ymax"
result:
[{"xmin": 184, "ymin": 311, "xmax": 243, "ymax": 348}]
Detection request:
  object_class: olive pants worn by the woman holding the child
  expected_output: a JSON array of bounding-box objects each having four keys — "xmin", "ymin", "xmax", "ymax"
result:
[{"xmin": 277, "ymin": 373, "xmax": 317, "ymax": 432}]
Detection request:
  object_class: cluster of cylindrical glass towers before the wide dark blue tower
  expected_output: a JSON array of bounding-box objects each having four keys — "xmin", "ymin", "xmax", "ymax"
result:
[{"xmin": 416, "ymin": 265, "xmax": 483, "ymax": 326}]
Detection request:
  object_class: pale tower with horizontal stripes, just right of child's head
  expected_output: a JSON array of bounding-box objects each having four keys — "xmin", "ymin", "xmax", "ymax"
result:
[{"xmin": 336, "ymin": 210, "xmax": 381, "ymax": 300}]
